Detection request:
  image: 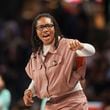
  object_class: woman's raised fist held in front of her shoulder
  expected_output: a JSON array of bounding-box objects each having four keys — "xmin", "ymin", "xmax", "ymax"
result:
[{"xmin": 68, "ymin": 39, "xmax": 84, "ymax": 51}]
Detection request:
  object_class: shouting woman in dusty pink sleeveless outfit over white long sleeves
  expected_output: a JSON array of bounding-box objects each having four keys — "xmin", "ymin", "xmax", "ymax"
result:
[{"xmin": 23, "ymin": 13, "xmax": 95, "ymax": 110}]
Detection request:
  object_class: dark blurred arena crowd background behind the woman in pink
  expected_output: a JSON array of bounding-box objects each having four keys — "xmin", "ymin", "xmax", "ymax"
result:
[{"xmin": 0, "ymin": 0, "xmax": 110, "ymax": 110}]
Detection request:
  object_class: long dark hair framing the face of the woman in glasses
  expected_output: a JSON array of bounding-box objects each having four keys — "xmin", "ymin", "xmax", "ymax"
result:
[{"xmin": 31, "ymin": 13, "xmax": 62, "ymax": 53}]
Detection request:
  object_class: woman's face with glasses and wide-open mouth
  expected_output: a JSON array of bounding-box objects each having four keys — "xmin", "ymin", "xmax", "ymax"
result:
[{"xmin": 36, "ymin": 17, "xmax": 55, "ymax": 45}]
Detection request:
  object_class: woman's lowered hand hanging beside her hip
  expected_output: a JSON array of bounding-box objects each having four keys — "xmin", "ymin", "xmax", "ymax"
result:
[{"xmin": 23, "ymin": 89, "xmax": 34, "ymax": 106}]
